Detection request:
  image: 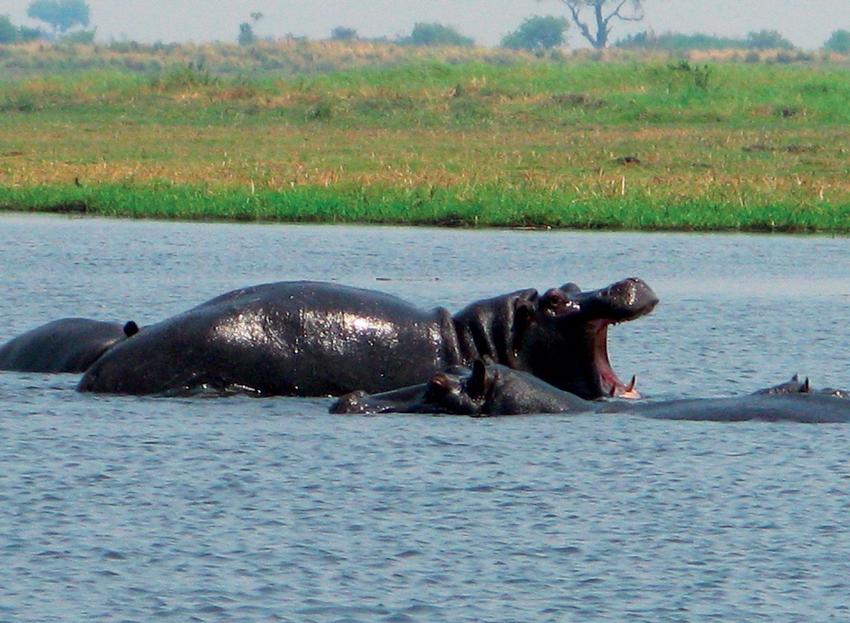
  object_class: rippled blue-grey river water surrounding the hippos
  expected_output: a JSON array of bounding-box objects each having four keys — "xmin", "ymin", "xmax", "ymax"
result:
[{"xmin": 0, "ymin": 215, "xmax": 850, "ymax": 623}]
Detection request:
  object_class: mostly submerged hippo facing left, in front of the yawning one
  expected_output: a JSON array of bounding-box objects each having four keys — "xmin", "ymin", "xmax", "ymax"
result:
[{"xmin": 330, "ymin": 361, "xmax": 850, "ymax": 423}]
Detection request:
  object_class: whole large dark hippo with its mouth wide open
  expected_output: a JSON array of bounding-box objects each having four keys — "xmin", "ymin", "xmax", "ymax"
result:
[{"xmin": 78, "ymin": 278, "xmax": 658, "ymax": 398}]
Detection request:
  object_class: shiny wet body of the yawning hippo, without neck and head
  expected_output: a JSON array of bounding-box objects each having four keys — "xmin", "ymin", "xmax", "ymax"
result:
[{"xmin": 79, "ymin": 282, "xmax": 459, "ymax": 395}]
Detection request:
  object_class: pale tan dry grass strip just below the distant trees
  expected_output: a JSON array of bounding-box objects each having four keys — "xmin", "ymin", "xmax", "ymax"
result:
[{"xmin": 0, "ymin": 39, "xmax": 847, "ymax": 82}]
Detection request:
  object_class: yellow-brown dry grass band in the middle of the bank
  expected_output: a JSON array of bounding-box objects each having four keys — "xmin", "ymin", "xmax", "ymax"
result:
[{"xmin": 0, "ymin": 125, "xmax": 850, "ymax": 210}]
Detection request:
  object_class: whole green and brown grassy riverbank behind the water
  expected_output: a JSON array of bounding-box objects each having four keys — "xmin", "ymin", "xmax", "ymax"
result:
[{"xmin": 0, "ymin": 44, "xmax": 850, "ymax": 232}]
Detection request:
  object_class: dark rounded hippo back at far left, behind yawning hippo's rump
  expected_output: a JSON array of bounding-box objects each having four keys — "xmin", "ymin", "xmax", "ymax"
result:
[{"xmin": 0, "ymin": 318, "xmax": 139, "ymax": 373}]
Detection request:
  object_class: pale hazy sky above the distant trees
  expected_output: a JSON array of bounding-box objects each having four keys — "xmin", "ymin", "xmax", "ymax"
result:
[{"xmin": 0, "ymin": 0, "xmax": 850, "ymax": 48}]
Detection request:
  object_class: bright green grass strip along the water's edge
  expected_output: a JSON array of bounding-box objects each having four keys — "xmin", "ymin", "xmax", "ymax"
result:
[{"xmin": 0, "ymin": 185, "xmax": 850, "ymax": 235}]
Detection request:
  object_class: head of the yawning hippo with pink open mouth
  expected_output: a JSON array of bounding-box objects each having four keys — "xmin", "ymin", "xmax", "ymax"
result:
[{"xmin": 512, "ymin": 278, "xmax": 658, "ymax": 399}]
